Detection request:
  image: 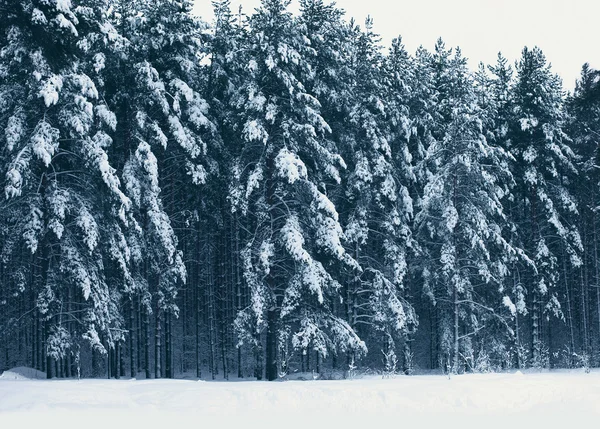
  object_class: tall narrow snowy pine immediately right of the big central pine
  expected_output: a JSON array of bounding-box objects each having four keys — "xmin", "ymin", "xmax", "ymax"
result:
[{"xmin": 341, "ymin": 19, "xmax": 417, "ymax": 371}]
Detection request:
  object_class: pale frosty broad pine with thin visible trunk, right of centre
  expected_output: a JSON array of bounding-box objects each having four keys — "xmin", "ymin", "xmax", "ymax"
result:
[{"xmin": 415, "ymin": 40, "xmax": 515, "ymax": 373}]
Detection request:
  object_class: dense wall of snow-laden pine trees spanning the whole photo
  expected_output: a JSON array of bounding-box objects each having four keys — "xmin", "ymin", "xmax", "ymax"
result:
[{"xmin": 0, "ymin": 0, "xmax": 600, "ymax": 380}]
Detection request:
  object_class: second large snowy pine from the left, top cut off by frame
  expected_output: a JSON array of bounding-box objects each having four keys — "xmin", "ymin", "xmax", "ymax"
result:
[{"xmin": 106, "ymin": 0, "xmax": 216, "ymax": 377}]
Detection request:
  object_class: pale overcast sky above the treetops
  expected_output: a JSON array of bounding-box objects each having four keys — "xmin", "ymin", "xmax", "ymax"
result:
[{"xmin": 195, "ymin": 0, "xmax": 600, "ymax": 89}]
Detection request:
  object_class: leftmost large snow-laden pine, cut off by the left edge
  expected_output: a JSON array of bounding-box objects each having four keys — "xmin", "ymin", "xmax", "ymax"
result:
[{"xmin": 0, "ymin": 0, "xmax": 130, "ymax": 377}]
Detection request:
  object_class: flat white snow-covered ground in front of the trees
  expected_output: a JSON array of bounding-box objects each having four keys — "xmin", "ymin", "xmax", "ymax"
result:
[{"xmin": 0, "ymin": 372, "xmax": 600, "ymax": 429}]
